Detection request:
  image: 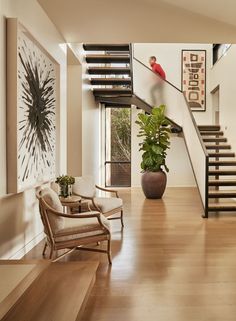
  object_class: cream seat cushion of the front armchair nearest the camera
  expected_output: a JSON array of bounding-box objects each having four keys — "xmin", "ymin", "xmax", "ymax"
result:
[{"xmin": 55, "ymin": 212, "xmax": 110, "ymax": 241}]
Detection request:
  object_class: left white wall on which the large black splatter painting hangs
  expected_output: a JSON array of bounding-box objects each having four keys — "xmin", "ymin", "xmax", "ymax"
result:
[{"xmin": 0, "ymin": 0, "xmax": 67, "ymax": 258}]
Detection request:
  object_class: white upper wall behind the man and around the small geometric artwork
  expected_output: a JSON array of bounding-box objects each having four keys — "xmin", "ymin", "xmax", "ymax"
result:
[{"xmin": 134, "ymin": 43, "xmax": 212, "ymax": 125}]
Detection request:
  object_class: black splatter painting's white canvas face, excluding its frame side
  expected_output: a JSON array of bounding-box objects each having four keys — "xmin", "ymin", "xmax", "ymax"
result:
[{"xmin": 17, "ymin": 28, "xmax": 56, "ymax": 190}]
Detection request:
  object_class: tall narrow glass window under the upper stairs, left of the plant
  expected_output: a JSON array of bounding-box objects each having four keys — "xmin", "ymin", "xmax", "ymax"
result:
[{"xmin": 105, "ymin": 107, "xmax": 131, "ymax": 187}]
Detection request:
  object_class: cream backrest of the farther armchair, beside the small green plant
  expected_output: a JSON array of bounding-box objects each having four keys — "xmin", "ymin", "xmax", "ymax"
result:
[{"xmin": 72, "ymin": 176, "xmax": 96, "ymax": 198}]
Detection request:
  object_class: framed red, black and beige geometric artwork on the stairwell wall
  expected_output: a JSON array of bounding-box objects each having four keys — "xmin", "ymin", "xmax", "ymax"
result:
[{"xmin": 181, "ymin": 50, "xmax": 206, "ymax": 111}]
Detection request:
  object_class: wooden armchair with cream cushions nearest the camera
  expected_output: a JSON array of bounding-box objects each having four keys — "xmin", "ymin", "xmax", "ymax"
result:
[{"xmin": 37, "ymin": 187, "xmax": 111, "ymax": 264}]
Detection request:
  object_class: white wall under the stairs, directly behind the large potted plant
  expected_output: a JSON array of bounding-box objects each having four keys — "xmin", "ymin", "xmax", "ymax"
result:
[{"xmin": 131, "ymin": 107, "xmax": 196, "ymax": 187}]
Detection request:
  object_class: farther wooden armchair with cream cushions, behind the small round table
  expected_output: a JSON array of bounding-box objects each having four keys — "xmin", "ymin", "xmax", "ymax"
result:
[{"xmin": 73, "ymin": 176, "xmax": 124, "ymax": 227}]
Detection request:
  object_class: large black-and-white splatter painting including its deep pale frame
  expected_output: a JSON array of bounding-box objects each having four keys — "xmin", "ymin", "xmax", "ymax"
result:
[{"xmin": 7, "ymin": 18, "xmax": 59, "ymax": 193}]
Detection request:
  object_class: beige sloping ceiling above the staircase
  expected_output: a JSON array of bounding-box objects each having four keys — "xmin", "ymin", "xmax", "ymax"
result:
[{"xmin": 38, "ymin": 0, "xmax": 236, "ymax": 43}]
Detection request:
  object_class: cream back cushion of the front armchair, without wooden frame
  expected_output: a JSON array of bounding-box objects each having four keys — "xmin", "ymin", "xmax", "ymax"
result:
[{"xmin": 41, "ymin": 187, "xmax": 64, "ymax": 233}]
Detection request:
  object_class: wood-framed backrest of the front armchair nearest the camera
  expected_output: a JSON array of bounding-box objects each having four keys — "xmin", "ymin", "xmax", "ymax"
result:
[{"xmin": 37, "ymin": 187, "xmax": 64, "ymax": 235}]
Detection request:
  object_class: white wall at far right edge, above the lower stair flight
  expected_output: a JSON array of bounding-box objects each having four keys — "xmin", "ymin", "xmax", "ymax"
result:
[{"xmin": 209, "ymin": 45, "xmax": 236, "ymax": 151}]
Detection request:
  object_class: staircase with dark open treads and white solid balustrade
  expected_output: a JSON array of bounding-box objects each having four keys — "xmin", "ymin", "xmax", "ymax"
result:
[{"xmin": 83, "ymin": 44, "xmax": 236, "ymax": 217}]
